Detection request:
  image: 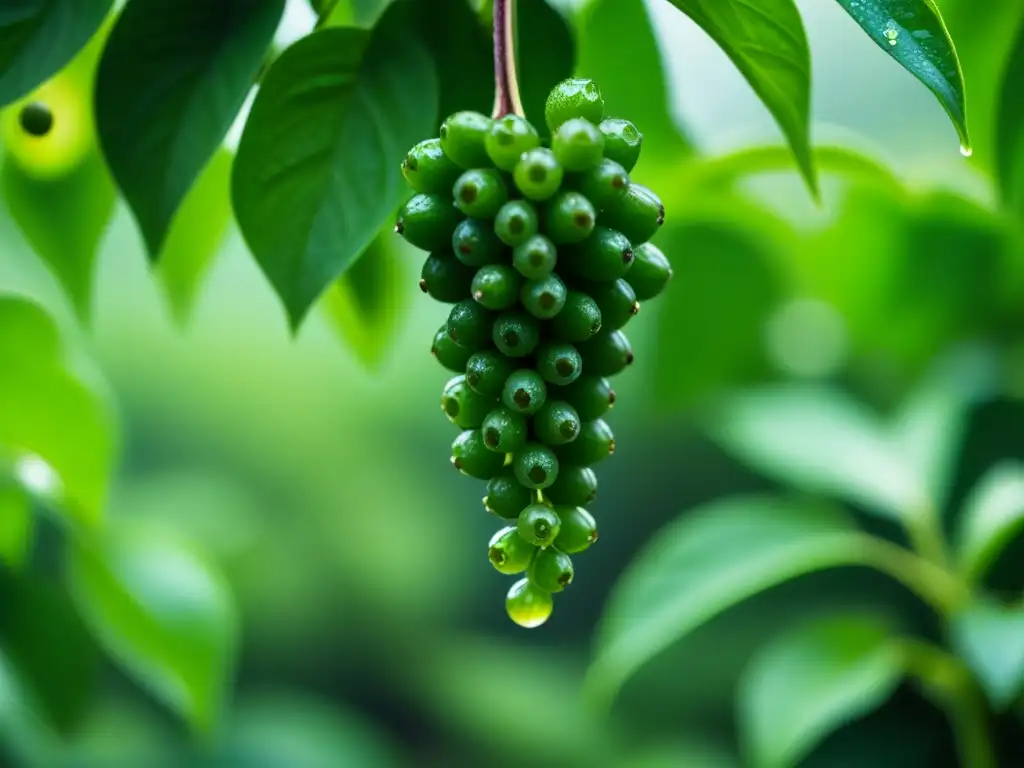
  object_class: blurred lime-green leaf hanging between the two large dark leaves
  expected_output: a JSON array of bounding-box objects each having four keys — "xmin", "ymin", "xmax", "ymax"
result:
[{"xmin": 157, "ymin": 148, "xmax": 233, "ymax": 325}]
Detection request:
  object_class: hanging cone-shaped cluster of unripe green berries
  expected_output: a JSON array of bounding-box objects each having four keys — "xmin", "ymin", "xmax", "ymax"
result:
[{"xmin": 395, "ymin": 80, "xmax": 672, "ymax": 627}]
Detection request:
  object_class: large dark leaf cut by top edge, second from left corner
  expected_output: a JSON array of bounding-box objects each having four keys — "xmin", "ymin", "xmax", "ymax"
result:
[{"xmin": 96, "ymin": 0, "xmax": 285, "ymax": 260}]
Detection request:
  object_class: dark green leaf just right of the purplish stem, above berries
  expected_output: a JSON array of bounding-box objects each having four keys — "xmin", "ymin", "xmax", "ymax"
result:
[{"xmin": 520, "ymin": 0, "xmax": 577, "ymax": 133}]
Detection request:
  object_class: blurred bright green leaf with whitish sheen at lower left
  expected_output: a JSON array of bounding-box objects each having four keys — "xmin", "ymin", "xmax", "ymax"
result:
[{"xmin": 67, "ymin": 522, "xmax": 237, "ymax": 732}]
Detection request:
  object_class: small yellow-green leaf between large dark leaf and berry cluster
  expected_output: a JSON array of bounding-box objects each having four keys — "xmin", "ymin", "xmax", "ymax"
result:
[{"xmin": 323, "ymin": 227, "xmax": 413, "ymax": 371}]
